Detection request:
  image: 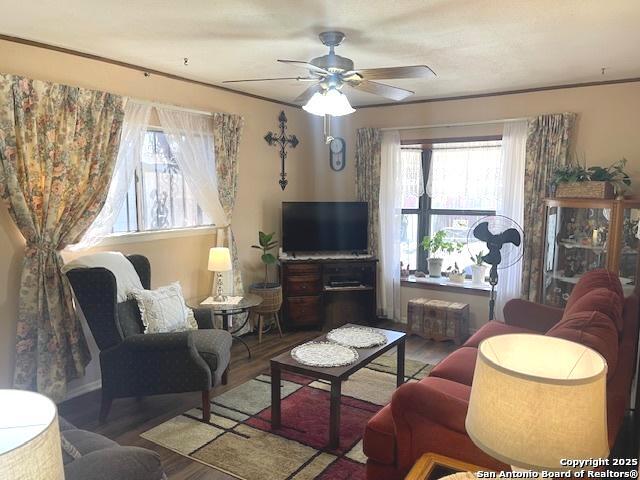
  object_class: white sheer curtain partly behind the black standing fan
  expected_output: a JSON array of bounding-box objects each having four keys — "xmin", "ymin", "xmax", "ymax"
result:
[{"xmin": 495, "ymin": 120, "xmax": 527, "ymax": 321}]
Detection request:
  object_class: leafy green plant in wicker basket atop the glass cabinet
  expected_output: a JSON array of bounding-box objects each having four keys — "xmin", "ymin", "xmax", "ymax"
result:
[{"xmin": 552, "ymin": 158, "xmax": 631, "ymax": 199}]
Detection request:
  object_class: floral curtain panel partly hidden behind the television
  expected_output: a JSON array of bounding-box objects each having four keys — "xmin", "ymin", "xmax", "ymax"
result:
[{"xmin": 356, "ymin": 128, "xmax": 382, "ymax": 255}]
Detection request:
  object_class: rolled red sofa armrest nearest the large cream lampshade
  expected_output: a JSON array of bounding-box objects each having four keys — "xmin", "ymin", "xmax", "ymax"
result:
[{"xmin": 391, "ymin": 382, "xmax": 469, "ymax": 434}]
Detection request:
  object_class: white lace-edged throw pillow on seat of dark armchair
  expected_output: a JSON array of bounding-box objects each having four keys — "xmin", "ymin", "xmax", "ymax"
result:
[{"xmin": 129, "ymin": 282, "xmax": 198, "ymax": 333}]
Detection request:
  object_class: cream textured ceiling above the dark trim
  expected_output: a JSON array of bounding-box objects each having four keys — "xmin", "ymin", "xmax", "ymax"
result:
[{"xmin": 0, "ymin": 0, "xmax": 640, "ymax": 105}]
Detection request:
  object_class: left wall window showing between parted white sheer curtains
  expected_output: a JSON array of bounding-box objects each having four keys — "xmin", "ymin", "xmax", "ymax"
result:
[{"xmin": 113, "ymin": 130, "xmax": 212, "ymax": 233}]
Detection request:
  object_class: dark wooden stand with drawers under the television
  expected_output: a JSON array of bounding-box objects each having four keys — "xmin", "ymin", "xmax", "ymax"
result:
[{"xmin": 280, "ymin": 253, "xmax": 378, "ymax": 330}]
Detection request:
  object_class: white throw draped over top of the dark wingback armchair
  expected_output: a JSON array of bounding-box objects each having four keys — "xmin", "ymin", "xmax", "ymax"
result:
[{"xmin": 62, "ymin": 252, "xmax": 142, "ymax": 303}]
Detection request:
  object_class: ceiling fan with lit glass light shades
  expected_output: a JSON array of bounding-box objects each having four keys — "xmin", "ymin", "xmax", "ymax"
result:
[{"xmin": 223, "ymin": 31, "xmax": 435, "ymax": 116}]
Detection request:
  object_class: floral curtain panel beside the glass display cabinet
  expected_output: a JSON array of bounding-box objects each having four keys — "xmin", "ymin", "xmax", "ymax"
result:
[{"xmin": 522, "ymin": 113, "xmax": 576, "ymax": 301}]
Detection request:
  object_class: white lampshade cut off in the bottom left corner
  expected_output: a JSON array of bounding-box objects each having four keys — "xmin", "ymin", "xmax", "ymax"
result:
[{"xmin": 0, "ymin": 390, "xmax": 64, "ymax": 480}]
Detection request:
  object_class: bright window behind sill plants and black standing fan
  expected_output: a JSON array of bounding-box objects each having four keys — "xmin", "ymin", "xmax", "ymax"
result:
[{"xmin": 400, "ymin": 140, "xmax": 502, "ymax": 274}]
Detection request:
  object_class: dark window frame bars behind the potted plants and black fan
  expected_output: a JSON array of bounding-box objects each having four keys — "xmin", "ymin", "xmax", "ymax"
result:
[{"xmin": 400, "ymin": 135, "xmax": 502, "ymax": 277}]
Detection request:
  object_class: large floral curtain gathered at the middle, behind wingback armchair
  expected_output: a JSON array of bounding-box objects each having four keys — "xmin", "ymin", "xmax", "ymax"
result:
[{"xmin": 0, "ymin": 75, "xmax": 124, "ymax": 400}]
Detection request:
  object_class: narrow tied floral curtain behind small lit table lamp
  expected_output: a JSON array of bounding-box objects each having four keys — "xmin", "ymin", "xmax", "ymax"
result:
[{"xmin": 213, "ymin": 113, "xmax": 249, "ymax": 334}]
